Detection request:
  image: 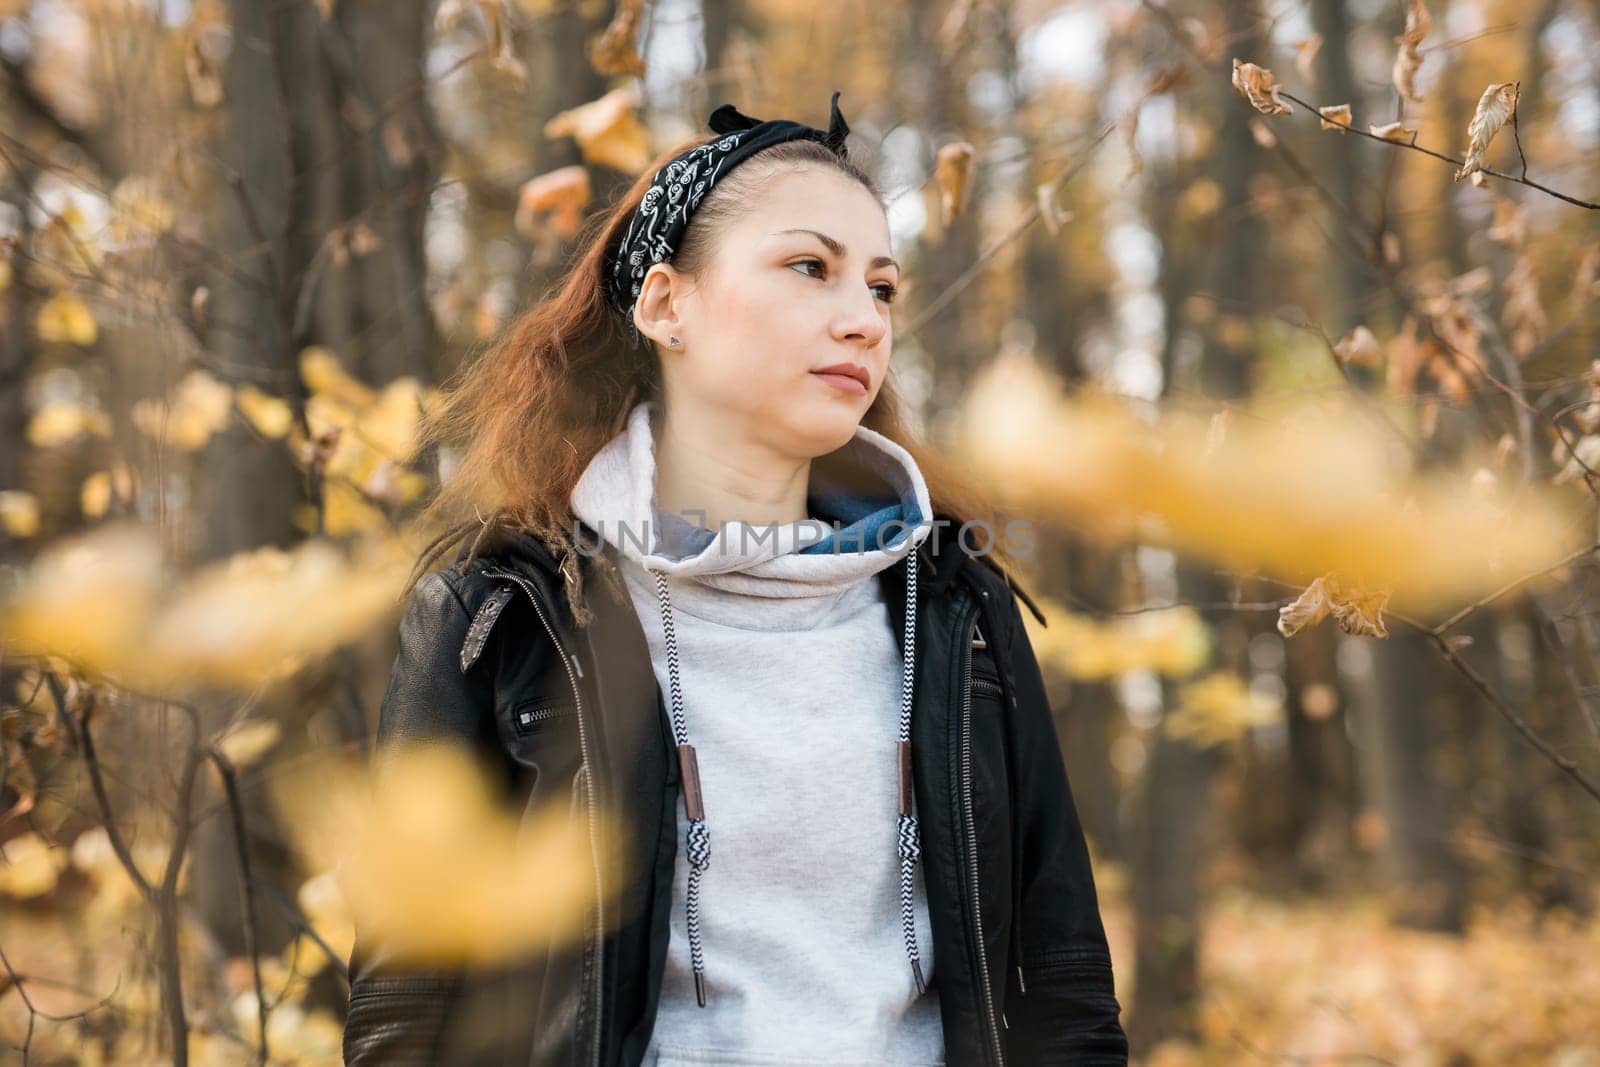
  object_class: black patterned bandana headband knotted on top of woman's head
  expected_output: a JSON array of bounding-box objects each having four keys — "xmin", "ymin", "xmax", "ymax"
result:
[{"xmin": 606, "ymin": 90, "xmax": 850, "ymax": 341}]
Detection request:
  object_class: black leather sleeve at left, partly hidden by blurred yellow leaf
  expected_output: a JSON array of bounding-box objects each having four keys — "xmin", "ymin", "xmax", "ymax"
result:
[{"xmin": 344, "ymin": 571, "xmax": 494, "ymax": 1067}]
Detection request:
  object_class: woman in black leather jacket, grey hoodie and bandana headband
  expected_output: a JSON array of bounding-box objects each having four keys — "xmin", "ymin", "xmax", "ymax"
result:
[{"xmin": 346, "ymin": 93, "xmax": 1126, "ymax": 1065}]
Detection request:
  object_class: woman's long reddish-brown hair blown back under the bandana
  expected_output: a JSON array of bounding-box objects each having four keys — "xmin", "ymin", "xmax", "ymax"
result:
[{"xmin": 411, "ymin": 134, "xmax": 1006, "ymax": 625}]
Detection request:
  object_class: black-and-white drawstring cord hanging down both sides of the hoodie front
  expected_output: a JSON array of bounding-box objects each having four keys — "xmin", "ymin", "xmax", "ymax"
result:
[{"xmin": 651, "ymin": 545, "xmax": 928, "ymax": 1008}]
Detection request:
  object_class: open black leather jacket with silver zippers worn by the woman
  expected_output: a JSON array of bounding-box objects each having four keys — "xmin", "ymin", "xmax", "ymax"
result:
[{"xmin": 344, "ymin": 526, "xmax": 1128, "ymax": 1067}]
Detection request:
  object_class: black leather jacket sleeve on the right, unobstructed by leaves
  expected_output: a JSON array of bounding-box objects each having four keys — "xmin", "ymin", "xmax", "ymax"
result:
[{"xmin": 1003, "ymin": 579, "xmax": 1128, "ymax": 1065}]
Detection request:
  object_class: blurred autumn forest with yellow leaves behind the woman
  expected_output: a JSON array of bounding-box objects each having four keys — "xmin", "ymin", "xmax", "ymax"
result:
[{"xmin": 0, "ymin": 0, "xmax": 1600, "ymax": 1067}]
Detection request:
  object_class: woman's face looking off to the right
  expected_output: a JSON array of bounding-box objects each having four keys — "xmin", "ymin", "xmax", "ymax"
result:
[{"xmin": 646, "ymin": 168, "xmax": 899, "ymax": 458}]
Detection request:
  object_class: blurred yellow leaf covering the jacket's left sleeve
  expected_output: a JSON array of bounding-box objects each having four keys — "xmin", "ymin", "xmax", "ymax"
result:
[{"xmin": 272, "ymin": 744, "xmax": 618, "ymax": 963}]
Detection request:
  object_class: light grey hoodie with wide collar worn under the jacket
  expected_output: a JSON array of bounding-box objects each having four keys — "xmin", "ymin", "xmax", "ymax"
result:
[{"xmin": 571, "ymin": 402, "xmax": 944, "ymax": 1067}]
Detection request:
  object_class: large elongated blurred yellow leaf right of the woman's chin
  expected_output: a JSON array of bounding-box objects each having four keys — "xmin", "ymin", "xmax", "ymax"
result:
[{"xmin": 962, "ymin": 352, "xmax": 1582, "ymax": 609}]
